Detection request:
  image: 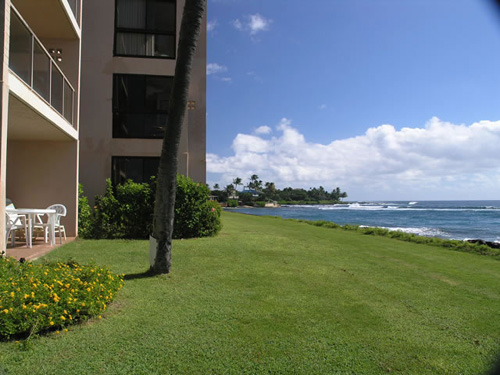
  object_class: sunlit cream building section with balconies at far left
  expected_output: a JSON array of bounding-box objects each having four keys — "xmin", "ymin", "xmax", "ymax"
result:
[{"xmin": 0, "ymin": 0, "xmax": 82, "ymax": 251}]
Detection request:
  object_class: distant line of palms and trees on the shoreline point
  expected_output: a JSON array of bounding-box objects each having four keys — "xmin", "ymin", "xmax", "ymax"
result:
[{"xmin": 211, "ymin": 174, "xmax": 347, "ymax": 206}]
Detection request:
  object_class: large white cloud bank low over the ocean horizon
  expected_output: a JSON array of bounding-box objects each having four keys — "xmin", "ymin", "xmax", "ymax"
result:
[{"xmin": 207, "ymin": 117, "xmax": 500, "ymax": 199}]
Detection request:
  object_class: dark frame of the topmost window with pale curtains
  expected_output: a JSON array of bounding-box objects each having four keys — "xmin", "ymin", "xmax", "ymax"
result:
[{"xmin": 113, "ymin": 0, "xmax": 177, "ymax": 60}]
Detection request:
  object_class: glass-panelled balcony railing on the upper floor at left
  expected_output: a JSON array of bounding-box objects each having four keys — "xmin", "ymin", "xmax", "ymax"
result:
[{"xmin": 9, "ymin": 7, "xmax": 75, "ymax": 126}]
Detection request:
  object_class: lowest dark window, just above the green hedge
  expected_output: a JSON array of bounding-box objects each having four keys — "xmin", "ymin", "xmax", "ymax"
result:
[{"xmin": 111, "ymin": 156, "xmax": 160, "ymax": 185}]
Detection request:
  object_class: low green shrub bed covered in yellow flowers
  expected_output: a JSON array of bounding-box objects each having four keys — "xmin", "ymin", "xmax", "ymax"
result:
[{"xmin": 0, "ymin": 258, "xmax": 123, "ymax": 339}]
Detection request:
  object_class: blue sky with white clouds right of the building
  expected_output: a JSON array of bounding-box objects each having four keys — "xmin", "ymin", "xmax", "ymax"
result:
[{"xmin": 207, "ymin": 0, "xmax": 500, "ymax": 200}]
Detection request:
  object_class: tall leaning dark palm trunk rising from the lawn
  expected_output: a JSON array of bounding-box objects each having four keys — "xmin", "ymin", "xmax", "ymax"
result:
[{"xmin": 150, "ymin": 0, "xmax": 206, "ymax": 274}]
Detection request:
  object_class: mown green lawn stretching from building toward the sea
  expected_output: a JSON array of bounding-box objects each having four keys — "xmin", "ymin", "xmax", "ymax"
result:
[{"xmin": 0, "ymin": 213, "xmax": 500, "ymax": 375}]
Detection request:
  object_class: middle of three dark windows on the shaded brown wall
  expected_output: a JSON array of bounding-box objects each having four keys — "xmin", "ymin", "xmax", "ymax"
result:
[{"xmin": 113, "ymin": 74, "xmax": 173, "ymax": 139}]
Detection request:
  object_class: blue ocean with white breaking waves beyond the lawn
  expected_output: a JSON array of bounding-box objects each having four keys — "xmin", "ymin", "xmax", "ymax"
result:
[{"xmin": 227, "ymin": 200, "xmax": 500, "ymax": 242}]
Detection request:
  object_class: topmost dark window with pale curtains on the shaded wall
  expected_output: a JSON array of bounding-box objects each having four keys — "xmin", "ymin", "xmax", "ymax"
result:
[{"xmin": 115, "ymin": 0, "xmax": 176, "ymax": 59}]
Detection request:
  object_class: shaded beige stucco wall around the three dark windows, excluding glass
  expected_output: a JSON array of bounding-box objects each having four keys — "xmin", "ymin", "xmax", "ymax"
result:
[{"xmin": 80, "ymin": 0, "xmax": 206, "ymax": 201}]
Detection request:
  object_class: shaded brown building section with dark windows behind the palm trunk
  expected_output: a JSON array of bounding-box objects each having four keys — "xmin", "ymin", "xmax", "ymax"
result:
[{"xmin": 80, "ymin": 0, "xmax": 206, "ymax": 201}]
